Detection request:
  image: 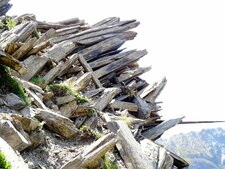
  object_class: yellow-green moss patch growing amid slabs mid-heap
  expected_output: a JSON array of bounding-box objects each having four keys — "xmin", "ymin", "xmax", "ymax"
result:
[{"xmin": 48, "ymin": 83, "xmax": 90, "ymax": 104}]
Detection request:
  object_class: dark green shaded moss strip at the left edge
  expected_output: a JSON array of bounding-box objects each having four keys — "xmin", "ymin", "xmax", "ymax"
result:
[{"xmin": 0, "ymin": 65, "xmax": 30, "ymax": 105}]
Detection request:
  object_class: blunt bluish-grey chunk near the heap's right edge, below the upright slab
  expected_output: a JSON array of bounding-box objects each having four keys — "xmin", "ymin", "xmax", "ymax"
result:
[{"xmin": 134, "ymin": 97, "xmax": 152, "ymax": 119}]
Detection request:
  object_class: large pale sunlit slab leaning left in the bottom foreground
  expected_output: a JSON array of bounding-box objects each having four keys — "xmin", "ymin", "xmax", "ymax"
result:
[{"xmin": 107, "ymin": 120, "xmax": 155, "ymax": 169}]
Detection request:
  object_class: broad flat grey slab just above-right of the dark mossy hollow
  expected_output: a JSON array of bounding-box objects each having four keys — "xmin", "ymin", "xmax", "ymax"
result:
[{"xmin": 21, "ymin": 55, "xmax": 49, "ymax": 80}]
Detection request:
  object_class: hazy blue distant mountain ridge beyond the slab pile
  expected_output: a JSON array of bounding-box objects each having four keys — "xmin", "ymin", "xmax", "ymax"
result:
[{"xmin": 159, "ymin": 128, "xmax": 225, "ymax": 169}]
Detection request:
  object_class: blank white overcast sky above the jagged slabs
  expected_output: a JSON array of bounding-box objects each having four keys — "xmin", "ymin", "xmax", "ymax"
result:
[{"xmin": 8, "ymin": 0, "xmax": 225, "ymax": 134}]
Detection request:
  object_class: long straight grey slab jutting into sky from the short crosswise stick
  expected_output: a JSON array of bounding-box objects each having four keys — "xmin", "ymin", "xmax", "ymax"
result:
[{"xmin": 95, "ymin": 50, "xmax": 147, "ymax": 78}]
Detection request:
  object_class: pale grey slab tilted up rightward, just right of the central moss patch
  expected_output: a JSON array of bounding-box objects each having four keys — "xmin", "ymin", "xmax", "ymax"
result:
[{"xmin": 94, "ymin": 87, "xmax": 121, "ymax": 111}]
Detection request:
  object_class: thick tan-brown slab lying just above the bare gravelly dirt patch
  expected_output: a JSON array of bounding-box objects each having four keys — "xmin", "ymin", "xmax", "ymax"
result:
[{"xmin": 35, "ymin": 109, "xmax": 79, "ymax": 138}]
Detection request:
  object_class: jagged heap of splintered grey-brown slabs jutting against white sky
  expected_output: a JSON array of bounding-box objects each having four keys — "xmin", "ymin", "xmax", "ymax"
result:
[{"xmin": 0, "ymin": 14, "xmax": 188, "ymax": 169}]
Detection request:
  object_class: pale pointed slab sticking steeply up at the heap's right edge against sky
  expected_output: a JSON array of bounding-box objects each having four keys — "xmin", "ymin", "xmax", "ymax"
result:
[{"xmin": 145, "ymin": 77, "xmax": 167, "ymax": 103}]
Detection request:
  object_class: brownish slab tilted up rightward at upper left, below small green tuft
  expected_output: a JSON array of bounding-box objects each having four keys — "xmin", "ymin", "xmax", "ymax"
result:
[{"xmin": 13, "ymin": 38, "xmax": 37, "ymax": 59}]
